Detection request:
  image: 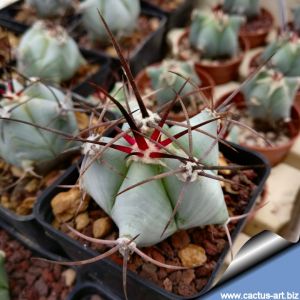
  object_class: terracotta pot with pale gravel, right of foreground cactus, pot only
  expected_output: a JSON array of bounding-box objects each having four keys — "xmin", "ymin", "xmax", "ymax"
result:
[{"xmin": 217, "ymin": 92, "xmax": 300, "ymax": 166}]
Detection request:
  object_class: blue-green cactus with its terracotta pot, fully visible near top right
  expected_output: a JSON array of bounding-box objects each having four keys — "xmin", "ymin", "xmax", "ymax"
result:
[{"xmin": 178, "ymin": 10, "xmax": 248, "ymax": 84}]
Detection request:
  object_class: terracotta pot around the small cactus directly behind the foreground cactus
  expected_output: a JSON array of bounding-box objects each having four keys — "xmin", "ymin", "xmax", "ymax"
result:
[{"xmin": 135, "ymin": 63, "xmax": 215, "ymax": 122}]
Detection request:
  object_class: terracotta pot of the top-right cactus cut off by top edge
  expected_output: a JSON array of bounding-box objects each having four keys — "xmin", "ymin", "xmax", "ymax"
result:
[{"xmin": 240, "ymin": 8, "xmax": 274, "ymax": 49}]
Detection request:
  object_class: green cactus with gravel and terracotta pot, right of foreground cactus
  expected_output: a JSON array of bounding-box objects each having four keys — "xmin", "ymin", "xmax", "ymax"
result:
[{"xmin": 219, "ymin": 69, "xmax": 300, "ymax": 166}]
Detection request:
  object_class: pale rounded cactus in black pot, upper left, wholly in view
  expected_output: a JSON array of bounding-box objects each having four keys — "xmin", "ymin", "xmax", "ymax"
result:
[{"xmin": 17, "ymin": 21, "xmax": 85, "ymax": 83}]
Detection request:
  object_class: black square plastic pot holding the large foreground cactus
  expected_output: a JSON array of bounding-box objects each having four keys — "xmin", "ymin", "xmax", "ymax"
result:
[{"xmin": 34, "ymin": 145, "xmax": 270, "ymax": 300}]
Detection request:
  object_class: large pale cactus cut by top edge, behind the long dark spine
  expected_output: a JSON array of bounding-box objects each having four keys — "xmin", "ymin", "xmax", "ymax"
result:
[{"xmin": 80, "ymin": 0, "xmax": 141, "ymax": 44}]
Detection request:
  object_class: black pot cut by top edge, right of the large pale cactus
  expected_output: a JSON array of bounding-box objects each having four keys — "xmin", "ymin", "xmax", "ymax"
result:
[{"xmin": 142, "ymin": 0, "xmax": 196, "ymax": 31}]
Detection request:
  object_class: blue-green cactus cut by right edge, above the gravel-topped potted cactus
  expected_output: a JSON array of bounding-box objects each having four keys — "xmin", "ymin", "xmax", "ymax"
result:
[{"xmin": 261, "ymin": 35, "xmax": 300, "ymax": 77}]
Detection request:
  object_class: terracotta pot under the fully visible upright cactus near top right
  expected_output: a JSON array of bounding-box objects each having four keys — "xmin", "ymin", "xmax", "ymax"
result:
[{"xmin": 178, "ymin": 30, "xmax": 249, "ymax": 84}]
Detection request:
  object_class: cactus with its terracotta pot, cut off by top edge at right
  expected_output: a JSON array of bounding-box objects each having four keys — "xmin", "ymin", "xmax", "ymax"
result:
[{"xmin": 222, "ymin": 0, "xmax": 274, "ymax": 48}]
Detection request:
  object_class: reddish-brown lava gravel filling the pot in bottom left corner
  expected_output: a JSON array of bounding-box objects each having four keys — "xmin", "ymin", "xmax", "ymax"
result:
[{"xmin": 0, "ymin": 229, "xmax": 71, "ymax": 300}]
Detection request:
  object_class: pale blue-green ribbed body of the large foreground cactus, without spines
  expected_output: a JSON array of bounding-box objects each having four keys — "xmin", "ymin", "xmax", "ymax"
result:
[{"xmin": 81, "ymin": 110, "xmax": 229, "ymax": 246}]
